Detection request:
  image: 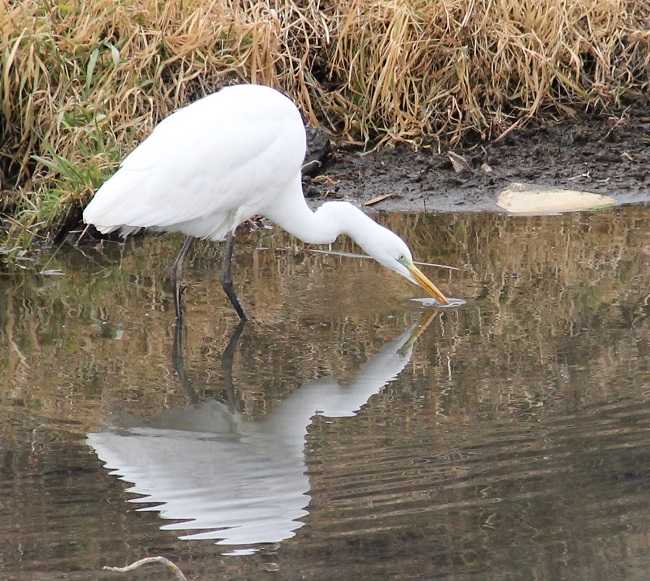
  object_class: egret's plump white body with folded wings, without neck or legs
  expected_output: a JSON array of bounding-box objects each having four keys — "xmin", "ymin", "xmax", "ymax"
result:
[{"xmin": 84, "ymin": 85, "xmax": 305, "ymax": 240}]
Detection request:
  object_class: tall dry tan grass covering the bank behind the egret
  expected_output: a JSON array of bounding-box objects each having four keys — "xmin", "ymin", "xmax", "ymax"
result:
[{"xmin": 0, "ymin": 0, "xmax": 650, "ymax": 245}]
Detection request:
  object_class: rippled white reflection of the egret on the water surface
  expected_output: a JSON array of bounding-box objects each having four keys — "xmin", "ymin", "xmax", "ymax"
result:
[{"xmin": 88, "ymin": 317, "xmax": 431, "ymax": 546}]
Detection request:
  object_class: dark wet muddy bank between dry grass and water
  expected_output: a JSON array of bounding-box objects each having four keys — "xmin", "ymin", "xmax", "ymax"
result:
[{"xmin": 305, "ymin": 110, "xmax": 650, "ymax": 212}]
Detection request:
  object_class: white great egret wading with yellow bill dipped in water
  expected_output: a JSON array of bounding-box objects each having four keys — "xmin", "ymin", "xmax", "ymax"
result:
[{"xmin": 83, "ymin": 85, "xmax": 448, "ymax": 320}]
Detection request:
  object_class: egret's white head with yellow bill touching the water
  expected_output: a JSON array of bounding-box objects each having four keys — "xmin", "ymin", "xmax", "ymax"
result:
[{"xmin": 358, "ymin": 223, "xmax": 449, "ymax": 305}]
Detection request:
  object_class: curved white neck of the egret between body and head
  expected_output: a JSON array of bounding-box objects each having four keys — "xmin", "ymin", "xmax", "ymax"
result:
[{"xmin": 263, "ymin": 176, "xmax": 384, "ymax": 248}]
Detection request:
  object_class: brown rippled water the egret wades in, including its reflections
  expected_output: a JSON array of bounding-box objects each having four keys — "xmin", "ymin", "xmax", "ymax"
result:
[{"xmin": 0, "ymin": 207, "xmax": 650, "ymax": 581}]
